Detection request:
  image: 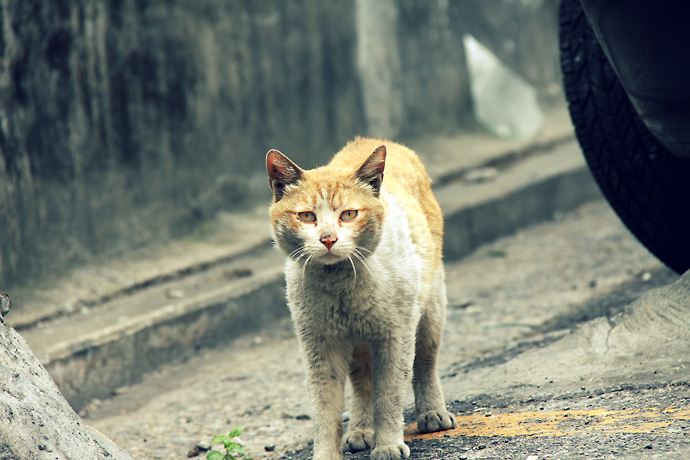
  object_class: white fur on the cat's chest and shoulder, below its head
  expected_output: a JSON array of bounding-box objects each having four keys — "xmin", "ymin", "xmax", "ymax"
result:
[{"xmin": 285, "ymin": 191, "xmax": 423, "ymax": 340}]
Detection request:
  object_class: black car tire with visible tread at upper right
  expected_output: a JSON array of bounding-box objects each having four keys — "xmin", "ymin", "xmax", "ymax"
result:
[{"xmin": 559, "ymin": 0, "xmax": 690, "ymax": 273}]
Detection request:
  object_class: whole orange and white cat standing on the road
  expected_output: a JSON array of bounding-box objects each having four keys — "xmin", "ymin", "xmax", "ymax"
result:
[{"xmin": 266, "ymin": 138, "xmax": 455, "ymax": 460}]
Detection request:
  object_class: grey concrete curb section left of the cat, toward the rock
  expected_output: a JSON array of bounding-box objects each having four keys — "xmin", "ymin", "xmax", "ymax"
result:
[{"xmin": 49, "ymin": 270, "xmax": 288, "ymax": 412}]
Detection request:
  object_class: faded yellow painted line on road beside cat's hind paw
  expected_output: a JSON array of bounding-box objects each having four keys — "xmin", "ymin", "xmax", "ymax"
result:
[{"xmin": 405, "ymin": 407, "xmax": 690, "ymax": 439}]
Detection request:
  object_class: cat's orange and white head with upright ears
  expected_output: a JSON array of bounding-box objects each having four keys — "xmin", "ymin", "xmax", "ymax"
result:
[{"xmin": 266, "ymin": 146, "xmax": 386, "ymax": 265}]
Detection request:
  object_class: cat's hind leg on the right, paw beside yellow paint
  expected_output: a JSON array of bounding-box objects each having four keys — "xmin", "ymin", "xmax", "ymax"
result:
[{"xmin": 412, "ymin": 272, "xmax": 455, "ymax": 433}]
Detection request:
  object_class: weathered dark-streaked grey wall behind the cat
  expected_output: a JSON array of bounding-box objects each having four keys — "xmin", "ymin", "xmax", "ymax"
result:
[{"xmin": 0, "ymin": 0, "xmax": 558, "ymax": 286}]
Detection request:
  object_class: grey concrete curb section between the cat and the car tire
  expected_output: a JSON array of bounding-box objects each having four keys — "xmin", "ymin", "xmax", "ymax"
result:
[{"xmin": 436, "ymin": 142, "xmax": 602, "ymax": 260}]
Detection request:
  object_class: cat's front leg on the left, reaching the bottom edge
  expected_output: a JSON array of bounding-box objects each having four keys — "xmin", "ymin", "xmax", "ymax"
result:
[{"xmin": 302, "ymin": 341, "xmax": 350, "ymax": 460}]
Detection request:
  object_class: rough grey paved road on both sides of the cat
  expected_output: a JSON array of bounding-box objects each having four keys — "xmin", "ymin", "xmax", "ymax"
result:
[{"xmin": 87, "ymin": 202, "xmax": 690, "ymax": 460}]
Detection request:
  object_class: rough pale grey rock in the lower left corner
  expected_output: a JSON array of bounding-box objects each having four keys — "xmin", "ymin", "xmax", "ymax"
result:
[{"xmin": 0, "ymin": 295, "xmax": 131, "ymax": 460}]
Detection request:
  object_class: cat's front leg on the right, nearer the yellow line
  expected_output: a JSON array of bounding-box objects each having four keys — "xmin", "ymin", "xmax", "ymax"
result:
[{"xmin": 371, "ymin": 333, "xmax": 414, "ymax": 460}]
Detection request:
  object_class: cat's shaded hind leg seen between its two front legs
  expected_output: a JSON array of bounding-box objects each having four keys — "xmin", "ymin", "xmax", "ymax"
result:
[{"xmin": 342, "ymin": 344, "xmax": 374, "ymax": 452}]
